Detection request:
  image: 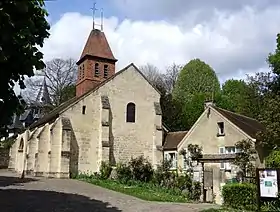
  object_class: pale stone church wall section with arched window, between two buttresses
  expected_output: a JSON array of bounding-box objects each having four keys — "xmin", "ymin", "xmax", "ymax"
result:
[{"xmin": 98, "ymin": 67, "xmax": 162, "ymax": 163}]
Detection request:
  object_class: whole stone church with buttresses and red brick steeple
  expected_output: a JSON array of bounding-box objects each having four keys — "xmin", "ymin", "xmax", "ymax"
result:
[{"xmin": 9, "ymin": 29, "xmax": 163, "ymax": 178}]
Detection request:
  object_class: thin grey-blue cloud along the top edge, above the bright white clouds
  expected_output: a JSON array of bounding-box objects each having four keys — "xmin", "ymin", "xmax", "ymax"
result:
[{"xmin": 112, "ymin": 0, "xmax": 280, "ymax": 21}]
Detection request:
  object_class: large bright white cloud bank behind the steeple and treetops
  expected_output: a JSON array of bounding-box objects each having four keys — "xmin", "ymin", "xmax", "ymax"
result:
[{"xmin": 42, "ymin": 4, "xmax": 280, "ymax": 82}]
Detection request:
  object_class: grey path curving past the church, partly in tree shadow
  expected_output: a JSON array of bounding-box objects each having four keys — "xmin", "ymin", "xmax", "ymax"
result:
[{"xmin": 0, "ymin": 170, "xmax": 217, "ymax": 212}]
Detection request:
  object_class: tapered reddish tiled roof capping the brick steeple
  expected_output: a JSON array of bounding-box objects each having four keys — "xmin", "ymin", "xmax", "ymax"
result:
[{"xmin": 77, "ymin": 29, "xmax": 117, "ymax": 64}]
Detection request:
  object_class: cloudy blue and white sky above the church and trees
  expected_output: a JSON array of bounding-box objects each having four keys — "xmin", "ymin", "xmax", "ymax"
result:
[{"xmin": 42, "ymin": 0, "xmax": 280, "ymax": 81}]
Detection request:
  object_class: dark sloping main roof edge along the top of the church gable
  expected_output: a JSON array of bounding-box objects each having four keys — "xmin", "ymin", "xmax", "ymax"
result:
[{"xmin": 29, "ymin": 63, "xmax": 161, "ymax": 129}]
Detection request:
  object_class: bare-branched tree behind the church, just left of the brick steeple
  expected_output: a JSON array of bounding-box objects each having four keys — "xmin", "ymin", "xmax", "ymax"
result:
[{"xmin": 26, "ymin": 58, "xmax": 77, "ymax": 106}]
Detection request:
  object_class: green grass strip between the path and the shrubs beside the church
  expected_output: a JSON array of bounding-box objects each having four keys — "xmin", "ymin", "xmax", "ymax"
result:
[{"xmin": 79, "ymin": 178, "xmax": 188, "ymax": 203}]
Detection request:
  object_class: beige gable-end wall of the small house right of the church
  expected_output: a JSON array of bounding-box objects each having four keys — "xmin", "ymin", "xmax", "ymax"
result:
[{"xmin": 178, "ymin": 108, "xmax": 259, "ymax": 204}]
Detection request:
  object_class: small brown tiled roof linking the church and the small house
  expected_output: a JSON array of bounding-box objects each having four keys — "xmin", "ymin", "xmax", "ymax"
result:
[{"xmin": 163, "ymin": 131, "xmax": 188, "ymax": 150}]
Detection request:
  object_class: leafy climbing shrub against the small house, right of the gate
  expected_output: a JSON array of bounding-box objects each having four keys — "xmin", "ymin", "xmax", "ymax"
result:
[{"xmin": 233, "ymin": 140, "xmax": 256, "ymax": 180}]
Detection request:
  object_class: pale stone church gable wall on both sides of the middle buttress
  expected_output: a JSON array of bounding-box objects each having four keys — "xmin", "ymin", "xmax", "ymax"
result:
[{"xmin": 61, "ymin": 67, "xmax": 162, "ymax": 172}]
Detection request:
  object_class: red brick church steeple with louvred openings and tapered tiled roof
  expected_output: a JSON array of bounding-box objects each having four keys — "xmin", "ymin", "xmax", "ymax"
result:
[{"xmin": 76, "ymin": 29, "xmax": 117, "ymax": 97}]
